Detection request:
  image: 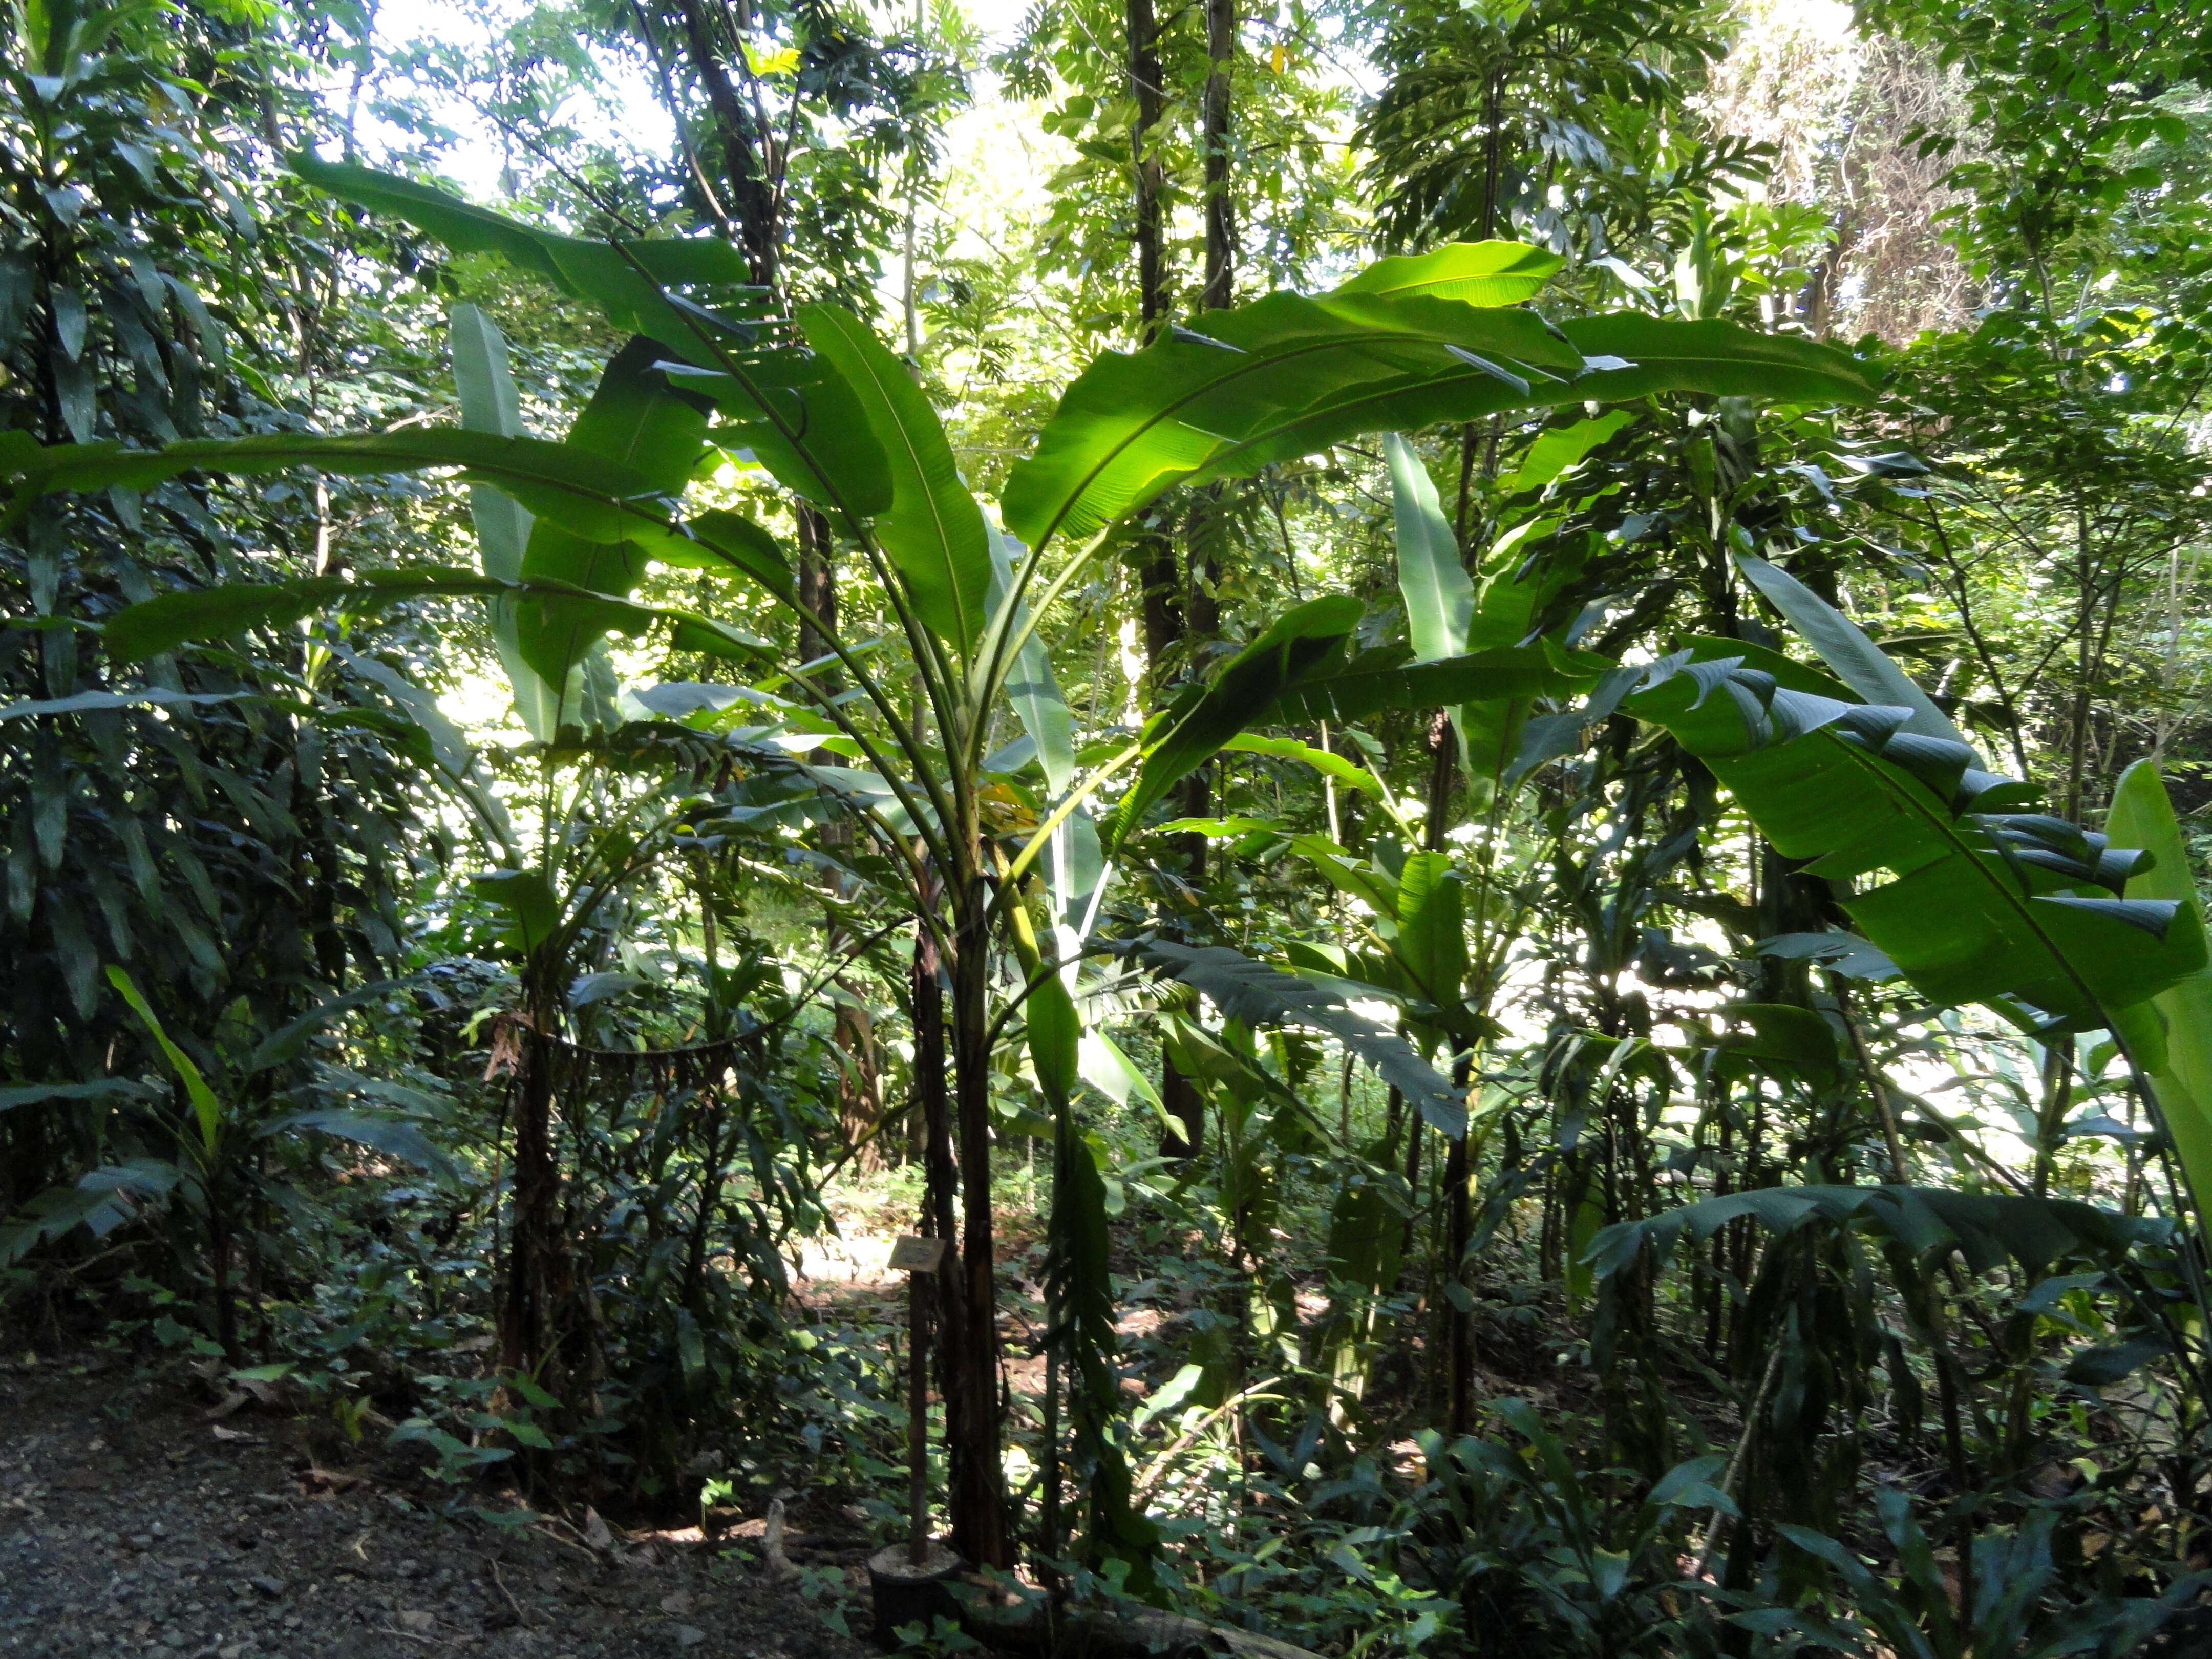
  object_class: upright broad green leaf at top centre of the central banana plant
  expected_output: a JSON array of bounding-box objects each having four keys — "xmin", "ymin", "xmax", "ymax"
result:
[{"xmin": 799, "ymin": 305, "xmax": 991, "ymax": 659}]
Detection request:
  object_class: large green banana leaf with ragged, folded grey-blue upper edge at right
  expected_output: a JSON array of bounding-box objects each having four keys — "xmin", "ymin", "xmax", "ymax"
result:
[{"xmin": 1624, "ymin": 652, "xmax": 2205, "ymax": 1029}]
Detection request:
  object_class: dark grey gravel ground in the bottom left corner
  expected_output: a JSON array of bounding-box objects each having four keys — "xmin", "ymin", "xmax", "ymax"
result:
[{"xmin": 0, "ymin": 1354, "xmax": 867, "ymax": 1659}]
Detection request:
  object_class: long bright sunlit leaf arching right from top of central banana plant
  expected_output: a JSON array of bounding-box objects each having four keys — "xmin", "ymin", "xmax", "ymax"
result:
[{"xmin": 1002, "ymin": 263, "xmax": 1874, "ymax": 546}]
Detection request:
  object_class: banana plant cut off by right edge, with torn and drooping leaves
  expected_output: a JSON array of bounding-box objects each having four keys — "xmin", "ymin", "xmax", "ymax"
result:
[{"xmin": 1586, "ymin": 553, "xmax": 2212, "ymax": 1424}]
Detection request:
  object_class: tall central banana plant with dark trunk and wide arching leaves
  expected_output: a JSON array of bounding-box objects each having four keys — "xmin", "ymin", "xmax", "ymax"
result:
[{"xmin": 0, "ymin": 157, "xmax": 1871, "ymax": 1566}]
